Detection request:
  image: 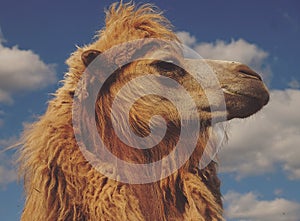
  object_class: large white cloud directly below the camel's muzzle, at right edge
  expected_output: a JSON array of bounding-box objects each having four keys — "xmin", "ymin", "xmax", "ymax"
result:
[{"xmin": 219, "ymin": 89, "xmax": 300, "ymax": 179}]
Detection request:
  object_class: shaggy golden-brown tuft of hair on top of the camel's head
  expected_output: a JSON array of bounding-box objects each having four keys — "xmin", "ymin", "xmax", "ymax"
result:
[{"xmin": 103, "ymin": 3, "xmax": 177, "ymax": 44}]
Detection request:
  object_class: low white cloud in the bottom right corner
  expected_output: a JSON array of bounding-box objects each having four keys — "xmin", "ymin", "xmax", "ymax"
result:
[{"xmin": 224, "ymin": 191, "xmax": 300, "ymax": 221}]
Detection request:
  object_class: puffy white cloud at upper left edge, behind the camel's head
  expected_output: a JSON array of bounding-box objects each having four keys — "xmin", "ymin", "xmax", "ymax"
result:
[{"xmin": 0, "ymin": 30, "xmax": 56, "ymax": 103}]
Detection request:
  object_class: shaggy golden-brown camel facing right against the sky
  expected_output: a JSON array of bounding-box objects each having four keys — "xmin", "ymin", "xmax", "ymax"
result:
[{"xmin": 20, "ymin": 2, "xmax": 269, "ymax": 221}]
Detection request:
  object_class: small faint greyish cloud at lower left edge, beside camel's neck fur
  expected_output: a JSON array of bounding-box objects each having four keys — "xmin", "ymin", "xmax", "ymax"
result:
[{"xmin": 0, "ymin": 137, "xmax": 18, "ymax": 188}]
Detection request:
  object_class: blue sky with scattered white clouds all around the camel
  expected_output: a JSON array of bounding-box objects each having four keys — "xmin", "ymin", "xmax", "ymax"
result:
[{"xmin": 0, "ymin": 0, "xmax": 300, "ymax": 221}]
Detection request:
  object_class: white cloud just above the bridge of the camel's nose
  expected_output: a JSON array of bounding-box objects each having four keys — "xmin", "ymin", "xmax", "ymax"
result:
[{"xmin": 177, "ymin": 31, "xmax": 271, "ymax": 81}]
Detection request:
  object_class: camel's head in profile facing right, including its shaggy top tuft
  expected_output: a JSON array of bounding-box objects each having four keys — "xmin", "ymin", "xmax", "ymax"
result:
[{"xmin": 72, "ymin": 1, "xmax": 269, "ymax": 181}]
